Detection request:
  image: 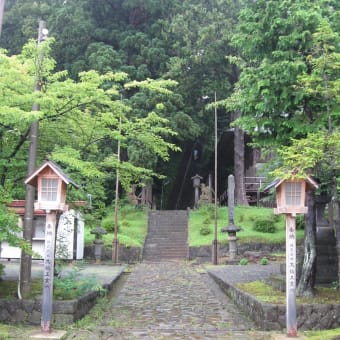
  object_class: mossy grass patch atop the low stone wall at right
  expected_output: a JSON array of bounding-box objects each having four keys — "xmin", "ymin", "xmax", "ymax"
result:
[{"xmin": 236, "ymin": 281, "xmax": 340, "ymax": 305}]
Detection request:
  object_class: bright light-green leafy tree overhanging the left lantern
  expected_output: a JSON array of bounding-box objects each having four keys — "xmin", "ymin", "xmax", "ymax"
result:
[{"xmin": 0, "ymin": 40, "xmax": 178, "ymax": 296}]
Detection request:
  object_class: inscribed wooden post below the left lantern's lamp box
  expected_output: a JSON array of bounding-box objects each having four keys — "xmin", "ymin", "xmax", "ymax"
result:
[{"xmin": 41, "ymin": 210, "xmax": 57, "ymax": 333}]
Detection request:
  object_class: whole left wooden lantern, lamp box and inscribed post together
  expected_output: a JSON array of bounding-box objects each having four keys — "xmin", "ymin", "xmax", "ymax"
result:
[{"xmin": 25, "ymin": 160, "xmax": 78, "ymax": 333}]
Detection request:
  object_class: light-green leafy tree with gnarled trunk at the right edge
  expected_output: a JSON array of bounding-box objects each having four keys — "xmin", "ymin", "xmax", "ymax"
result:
[{"xmin": 277, "ymin": 20, "xmax": 340, "ymax": 295}]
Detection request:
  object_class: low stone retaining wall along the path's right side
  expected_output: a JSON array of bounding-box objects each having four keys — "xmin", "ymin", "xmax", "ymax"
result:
[{"xmin": 209, "ymin": 273, "xmax": 340, "ymax": 331}]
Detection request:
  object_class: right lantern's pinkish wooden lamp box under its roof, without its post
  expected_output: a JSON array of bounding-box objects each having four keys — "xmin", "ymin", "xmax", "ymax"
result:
[{"xmin": 265, "ymin": 176, "xmax": 318, "ymax": 214}]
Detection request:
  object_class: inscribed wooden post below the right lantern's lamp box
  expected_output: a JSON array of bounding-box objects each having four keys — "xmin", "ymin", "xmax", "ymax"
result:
[{"xmin": 286, "ymin": 214, "xmax": 297, "ymax": 337}]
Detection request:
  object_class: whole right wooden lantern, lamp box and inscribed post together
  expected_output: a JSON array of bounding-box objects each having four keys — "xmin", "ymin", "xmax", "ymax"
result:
[{"xmin": 270, "ymin": 177, "xmax": 318, "ymax": 337}]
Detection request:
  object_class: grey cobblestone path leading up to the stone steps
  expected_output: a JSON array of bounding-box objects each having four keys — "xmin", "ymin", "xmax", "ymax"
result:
[{"xmin": 67, "ymin": 262, "xmax": 268, "ymax": 340}]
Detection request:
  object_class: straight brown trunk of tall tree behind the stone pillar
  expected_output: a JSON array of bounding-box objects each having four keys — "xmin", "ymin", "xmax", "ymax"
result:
[{"xmin": 234, "ymin": 122, "xmax": 249, "ymax": 205}]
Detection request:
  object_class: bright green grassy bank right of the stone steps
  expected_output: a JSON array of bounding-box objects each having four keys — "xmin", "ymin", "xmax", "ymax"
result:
[{"xmin": 189, "ymin": 206, "xmax": 303, "ymax": 246}]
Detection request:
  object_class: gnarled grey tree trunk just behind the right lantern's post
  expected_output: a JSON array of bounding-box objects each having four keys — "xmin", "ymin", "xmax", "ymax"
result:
[{"xmin": 296, "ymin": 190, "xmax": 316, "ymax": 296}]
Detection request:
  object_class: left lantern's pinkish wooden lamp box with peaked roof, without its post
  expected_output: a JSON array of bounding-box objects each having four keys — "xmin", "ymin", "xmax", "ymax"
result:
[{"xmin": 25, "ymin": 160, "xmax": 78, "ymax": 211}]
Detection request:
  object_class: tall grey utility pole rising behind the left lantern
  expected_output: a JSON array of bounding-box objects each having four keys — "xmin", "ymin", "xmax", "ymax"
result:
[{"xmin": 20, "ymin": 20, "xmax": 48, "ymax": 298}]
